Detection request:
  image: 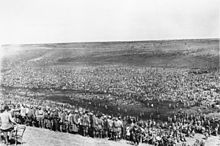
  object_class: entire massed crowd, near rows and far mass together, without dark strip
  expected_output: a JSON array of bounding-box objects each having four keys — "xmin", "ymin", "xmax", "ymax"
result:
[{"xmin": 1, "ymin": 52, "xmax": 220, "ymax": 145}]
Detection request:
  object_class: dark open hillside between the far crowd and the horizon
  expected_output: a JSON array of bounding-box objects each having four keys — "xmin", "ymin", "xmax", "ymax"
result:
[{"xmin": 3, "ymin": 39, "xmax": 219, "ymax": 68}]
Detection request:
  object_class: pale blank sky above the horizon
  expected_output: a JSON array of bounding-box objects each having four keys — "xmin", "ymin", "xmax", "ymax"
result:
[{"xmin": 0, "ymin": 0, "xmax": 220, "ymax": 44}]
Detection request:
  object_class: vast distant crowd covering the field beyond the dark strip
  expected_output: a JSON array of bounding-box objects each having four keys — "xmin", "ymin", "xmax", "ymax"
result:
[{"xmin": 1, "ymin": 63, "xmax": 220, "ymax": 107}]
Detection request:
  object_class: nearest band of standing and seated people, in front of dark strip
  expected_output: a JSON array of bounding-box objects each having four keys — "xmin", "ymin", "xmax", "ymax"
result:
[{"xmin": 1, "ymin": 94, "xmax": 219, "ymax": 145}]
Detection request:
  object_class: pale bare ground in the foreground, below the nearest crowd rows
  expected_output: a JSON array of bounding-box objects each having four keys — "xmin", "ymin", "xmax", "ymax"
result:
[{"xmin": 6, "ymin": 127, "xmax": 220, "ymax": 146}]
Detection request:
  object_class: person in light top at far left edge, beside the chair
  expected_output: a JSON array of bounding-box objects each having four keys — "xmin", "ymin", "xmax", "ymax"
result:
[{"xmin": 0, "ymin": 105, "xmax": 16, "ymax": 145}]
